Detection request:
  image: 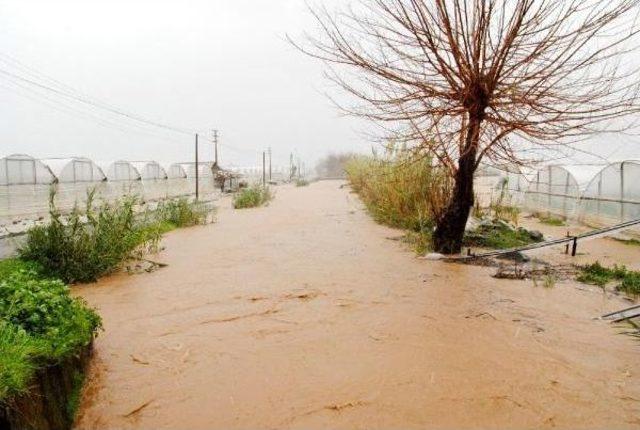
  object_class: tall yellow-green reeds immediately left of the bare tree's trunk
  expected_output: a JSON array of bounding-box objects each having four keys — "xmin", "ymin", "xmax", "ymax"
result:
[{"xmin": 345, "ymin": 151, "xmax": 451, "ymax": 252}]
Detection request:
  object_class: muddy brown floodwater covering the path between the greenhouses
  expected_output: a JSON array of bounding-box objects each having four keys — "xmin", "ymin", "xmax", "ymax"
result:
[{"xmin": 75, "ymin": 181, "xmax": 640, "ymax": 429}]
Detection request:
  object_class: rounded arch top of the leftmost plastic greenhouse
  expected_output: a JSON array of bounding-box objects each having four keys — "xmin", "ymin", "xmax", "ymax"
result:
[{"xmin": 0, "ymin": 154, "xmax": 56, "ymax": 185}]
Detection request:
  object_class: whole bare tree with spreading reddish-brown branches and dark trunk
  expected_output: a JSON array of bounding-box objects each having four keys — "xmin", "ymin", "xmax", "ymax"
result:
[{"xmin": 299, "ymin": 0, "xmax": 639, "ymax": 253}]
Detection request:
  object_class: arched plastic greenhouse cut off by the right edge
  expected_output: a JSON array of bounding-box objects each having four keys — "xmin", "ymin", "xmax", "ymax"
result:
[{"xmin": 578, "ymin": 160, "xmax": 640, "ymax": 226}]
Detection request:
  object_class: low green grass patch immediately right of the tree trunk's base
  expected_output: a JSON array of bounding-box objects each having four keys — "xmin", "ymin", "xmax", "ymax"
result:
[{"xmin": 464, "ymin": 220, "xmax": 543, "ymax": 249}]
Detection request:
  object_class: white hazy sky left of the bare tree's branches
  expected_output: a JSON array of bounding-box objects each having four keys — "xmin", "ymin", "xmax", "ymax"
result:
[{"xmin": 0, "ymin": 0, "xmax": 371, "ymax": 165}]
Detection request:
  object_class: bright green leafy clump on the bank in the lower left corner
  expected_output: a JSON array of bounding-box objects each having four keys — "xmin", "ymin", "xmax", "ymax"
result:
[{"xmin": 0, "ymin": 266, "xmax": 101, "ymax": 403}]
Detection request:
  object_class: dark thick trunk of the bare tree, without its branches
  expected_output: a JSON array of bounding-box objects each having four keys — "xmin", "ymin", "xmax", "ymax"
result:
[{"xmin": 433, "ymin": 119, "xmax": 481, "ymax": 254}]
